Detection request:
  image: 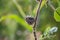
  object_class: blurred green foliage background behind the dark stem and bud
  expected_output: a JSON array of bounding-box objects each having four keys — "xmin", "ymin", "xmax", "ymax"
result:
[{"xmin": 0, "ymin": 0, "xmax": 60, "ymax": 40}]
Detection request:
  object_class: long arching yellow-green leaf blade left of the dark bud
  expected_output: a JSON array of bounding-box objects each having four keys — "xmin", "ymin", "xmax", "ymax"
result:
[{"xmin": 0, "ymin": 14, "xmax": 32, "ymax": 32}]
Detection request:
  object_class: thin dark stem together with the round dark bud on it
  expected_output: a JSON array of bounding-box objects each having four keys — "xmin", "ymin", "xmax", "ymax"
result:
[{"xmin": 26, "ymin": 0, "xmax": 42, "ymax": 40}]
